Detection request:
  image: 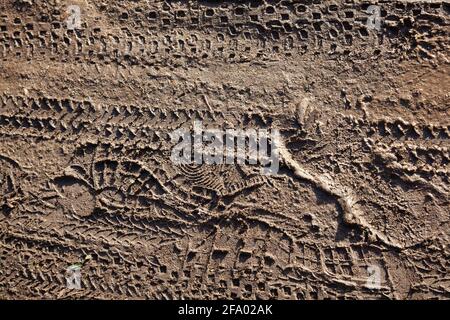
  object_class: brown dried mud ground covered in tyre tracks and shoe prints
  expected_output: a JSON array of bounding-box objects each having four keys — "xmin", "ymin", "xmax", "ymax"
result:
[{"xmin": 0, "ymin": 0, "xmax": 450, "ymax": 299}]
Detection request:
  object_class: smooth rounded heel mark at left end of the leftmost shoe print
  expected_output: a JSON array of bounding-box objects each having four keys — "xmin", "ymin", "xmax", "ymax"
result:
[{"xmin": 54, "ymin": 176, "xmax": 95, "ymax": 217}]
